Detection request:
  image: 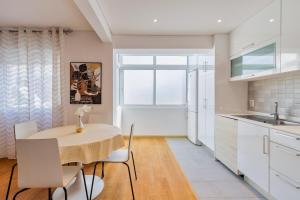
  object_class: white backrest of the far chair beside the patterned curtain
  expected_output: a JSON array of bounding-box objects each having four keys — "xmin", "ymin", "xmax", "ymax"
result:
[{"xmin": 14, "ymin": 121, "xmax": 38, "ymax": 140}]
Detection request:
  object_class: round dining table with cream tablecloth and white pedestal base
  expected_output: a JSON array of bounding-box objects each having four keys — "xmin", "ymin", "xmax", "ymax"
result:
[{"xmin": 28, "ymin": 124, "xmax": 124, "ymax": 200}]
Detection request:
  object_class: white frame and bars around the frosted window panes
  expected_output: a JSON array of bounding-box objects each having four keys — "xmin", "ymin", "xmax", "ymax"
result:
[{"xmin": 118, "ymin": 54, "xmax": 191, "ymax": 108}]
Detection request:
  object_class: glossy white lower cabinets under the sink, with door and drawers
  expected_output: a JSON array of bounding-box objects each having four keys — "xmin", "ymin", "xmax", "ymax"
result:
[{"xmin": 237, "ymin": 120, "xmax": 300, "ymax": 200}]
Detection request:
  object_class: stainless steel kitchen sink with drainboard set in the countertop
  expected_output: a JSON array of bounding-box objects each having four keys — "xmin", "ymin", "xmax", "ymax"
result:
[{"xmin": 234, "ymin": 115, "xmax": 300, "ymax": 125}]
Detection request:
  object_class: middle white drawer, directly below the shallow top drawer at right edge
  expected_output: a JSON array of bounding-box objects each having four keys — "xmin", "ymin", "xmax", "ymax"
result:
[{"xmin": 270, "ymin": 142, "xmax": 300, "ymax": 183}]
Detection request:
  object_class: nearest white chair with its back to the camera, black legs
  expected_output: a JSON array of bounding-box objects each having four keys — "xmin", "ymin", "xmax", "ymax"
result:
[{"xmin": 13, "ymin": 138, "xmax": 88, "ymax": 200}]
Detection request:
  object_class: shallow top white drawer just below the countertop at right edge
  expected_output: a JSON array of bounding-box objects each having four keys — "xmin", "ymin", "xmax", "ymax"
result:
[{"xmin": 270, "ymin": 129, "xmax": 300, "ymax": 151}]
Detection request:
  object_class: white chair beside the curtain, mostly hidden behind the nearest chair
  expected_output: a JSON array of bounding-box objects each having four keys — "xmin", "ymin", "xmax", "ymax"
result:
[{"xmin": 5, "ymin": 121, "xmax": 38, "ymax": 200}]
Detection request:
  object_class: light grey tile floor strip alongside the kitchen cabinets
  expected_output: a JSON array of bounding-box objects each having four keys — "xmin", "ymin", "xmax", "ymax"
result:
[{"xmin": 167, "ymin": 138, "xmax": 265, "ymax": 200}]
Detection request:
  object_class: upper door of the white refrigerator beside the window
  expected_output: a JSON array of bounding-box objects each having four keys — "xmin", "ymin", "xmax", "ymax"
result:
[{"xmin": 188, "ymin": 70, "xmax": 198, "ymax": 112}]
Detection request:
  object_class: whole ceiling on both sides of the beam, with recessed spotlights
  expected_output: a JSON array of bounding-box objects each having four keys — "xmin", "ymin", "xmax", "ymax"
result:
[{"xmin": 0, "ymin": 0, "xmax": 272, "ymax": 35}]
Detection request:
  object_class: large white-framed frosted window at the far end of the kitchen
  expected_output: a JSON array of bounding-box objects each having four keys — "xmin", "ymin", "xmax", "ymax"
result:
[{"xmin": 118, "ymin": 54, "xmax": 206, "ymax": 106}]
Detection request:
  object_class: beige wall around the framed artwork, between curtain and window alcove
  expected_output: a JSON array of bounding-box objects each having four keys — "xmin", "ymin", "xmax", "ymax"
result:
[{"xmin": 63, "ymin": 31, "xmax": 113, "ymax": 124}]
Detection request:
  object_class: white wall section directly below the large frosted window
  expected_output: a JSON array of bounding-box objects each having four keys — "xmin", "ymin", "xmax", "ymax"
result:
[{"xmin": 122, "ymin": 107, "xmax": 187, "ymax": 136}]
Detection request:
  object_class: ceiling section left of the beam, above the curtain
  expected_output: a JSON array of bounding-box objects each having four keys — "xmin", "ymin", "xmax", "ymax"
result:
[{"xmin": 0, "ymin": 0, "xmax": 92, "ymax": 30}]
